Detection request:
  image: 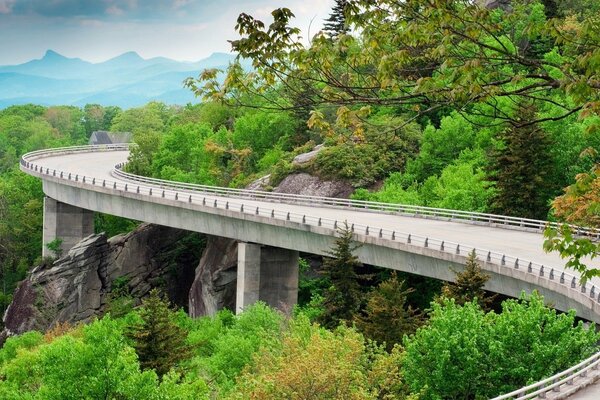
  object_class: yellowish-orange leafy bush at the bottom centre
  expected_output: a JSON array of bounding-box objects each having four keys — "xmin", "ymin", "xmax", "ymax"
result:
[{"xmin": 231, "ymin": 318, "xmax": 407, "ymax": 399}]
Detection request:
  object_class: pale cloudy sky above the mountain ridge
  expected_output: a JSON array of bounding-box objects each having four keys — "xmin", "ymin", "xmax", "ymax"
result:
[{"xmin": 0, "ymin": 0, "xmax": 334, "ymax": 65}]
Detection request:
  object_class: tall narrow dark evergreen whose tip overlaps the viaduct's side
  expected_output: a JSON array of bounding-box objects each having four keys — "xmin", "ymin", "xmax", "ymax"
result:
[{"xmin": 318, "ymin": 223, "xmax": 369, "ymax": 328}]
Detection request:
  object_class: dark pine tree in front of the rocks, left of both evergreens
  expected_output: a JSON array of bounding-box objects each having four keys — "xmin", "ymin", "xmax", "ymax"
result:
[{"xmin": 127, "ymin": 289, "xmax": 190, "ymax": 377}]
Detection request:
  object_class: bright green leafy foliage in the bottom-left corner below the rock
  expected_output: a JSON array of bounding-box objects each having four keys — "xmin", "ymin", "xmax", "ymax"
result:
[{"xmin": 0, "ymin": 317, "xmax": 207, "ymax": 400}]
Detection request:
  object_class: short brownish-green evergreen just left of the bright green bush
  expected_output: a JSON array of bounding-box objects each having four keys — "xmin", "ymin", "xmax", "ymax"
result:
[{"xmin": 356, "ymin": 272, "xmax": 423, "ymax": 351}]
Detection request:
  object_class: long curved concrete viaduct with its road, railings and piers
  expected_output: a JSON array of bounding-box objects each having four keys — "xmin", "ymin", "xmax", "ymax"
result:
[{"xmin": 21, "ymin": 145, "xmax": 600, "ymax": 399}]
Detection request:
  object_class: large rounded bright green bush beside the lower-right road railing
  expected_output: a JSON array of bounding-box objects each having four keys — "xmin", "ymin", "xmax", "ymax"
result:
[{"xmin": 404, "ymin": 293, "xmax": 598, "ymax": 399}]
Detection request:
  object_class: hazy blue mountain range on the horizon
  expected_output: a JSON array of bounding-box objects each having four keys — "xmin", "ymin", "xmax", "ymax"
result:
[{"xmin": 0, "ymin": 50, "xmax": 235, "ymax": 108}]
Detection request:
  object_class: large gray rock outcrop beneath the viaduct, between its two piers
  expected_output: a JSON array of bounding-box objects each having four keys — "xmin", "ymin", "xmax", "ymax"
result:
[{"xmin": 4, "ymin": 224, "xmax": 197, "ymax": 334}]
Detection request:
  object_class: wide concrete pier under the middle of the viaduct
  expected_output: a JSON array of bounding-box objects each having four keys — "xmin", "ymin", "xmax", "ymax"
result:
[{"xmin": 235, "ymin": 242, "xmax": 298, "ymax": 314}]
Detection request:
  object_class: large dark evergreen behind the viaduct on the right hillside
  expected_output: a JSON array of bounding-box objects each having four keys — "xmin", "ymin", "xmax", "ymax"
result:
[{"xmin": 489, "ymin": 100, "xmax": 552, "ymax": 219}]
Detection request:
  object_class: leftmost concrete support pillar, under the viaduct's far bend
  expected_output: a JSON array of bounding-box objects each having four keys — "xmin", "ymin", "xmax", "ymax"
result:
[{"xmin": 42, "ymin": 197, "xmax": 94, "ymax": 257}]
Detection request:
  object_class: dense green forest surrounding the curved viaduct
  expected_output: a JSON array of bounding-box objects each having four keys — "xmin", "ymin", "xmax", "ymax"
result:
[{"xmin": 0, "ymin": 0, "xmax": 600, "ymax": 399}]
